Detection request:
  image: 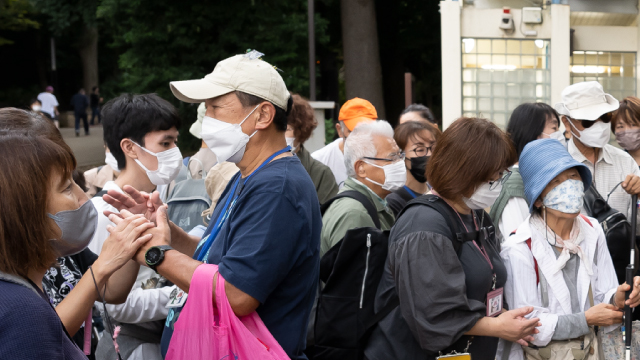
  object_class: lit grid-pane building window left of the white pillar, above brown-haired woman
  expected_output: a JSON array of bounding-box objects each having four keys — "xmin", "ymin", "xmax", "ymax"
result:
[{"xmin": 462, "ymin": 38, "xmax": 551, "ymax": 129}]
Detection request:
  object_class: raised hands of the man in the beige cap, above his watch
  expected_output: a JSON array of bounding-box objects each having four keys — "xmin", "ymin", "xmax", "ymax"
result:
[{"xmin": 102, "ymin": 185, "xmax": 171, "ymax": 265}]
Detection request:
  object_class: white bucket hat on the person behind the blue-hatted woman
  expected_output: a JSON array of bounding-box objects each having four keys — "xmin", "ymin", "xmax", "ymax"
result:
[{"xmin": 554, "ymin": 81, "xmax": 620, "ymax": 121}]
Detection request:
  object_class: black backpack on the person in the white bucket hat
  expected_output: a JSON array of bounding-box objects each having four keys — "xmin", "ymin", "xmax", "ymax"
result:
[{"xmin": 584, "ymin": 184, "xmax": 637, "ymax": 284}]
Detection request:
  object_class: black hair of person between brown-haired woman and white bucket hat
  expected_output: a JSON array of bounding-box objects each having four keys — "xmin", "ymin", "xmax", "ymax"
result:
[{"xmin": 507, "ymin": 103, "xmax": 560, "ymax": 158}]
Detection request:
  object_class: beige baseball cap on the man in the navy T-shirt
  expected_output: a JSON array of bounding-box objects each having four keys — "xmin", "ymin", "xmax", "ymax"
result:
[{"xmin": 169, "ymin": 51, "xmax": 290, "ymax": 111}]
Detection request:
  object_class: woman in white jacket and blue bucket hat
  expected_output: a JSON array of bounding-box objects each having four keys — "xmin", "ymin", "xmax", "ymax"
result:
[{"xmin": 496, "ymin": 139, "xmax": 640, "ymax": 360}]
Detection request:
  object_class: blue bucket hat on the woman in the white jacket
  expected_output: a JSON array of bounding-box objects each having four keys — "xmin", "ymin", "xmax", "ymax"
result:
[{"xmin": 519, "ymin": 139, "xmax": 592, "ymax": 212}]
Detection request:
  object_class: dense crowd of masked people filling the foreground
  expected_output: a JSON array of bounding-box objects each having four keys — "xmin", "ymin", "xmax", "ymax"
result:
[{"xmin": 0, "ymin": 51, "xmax": 640, "ymax": 360}]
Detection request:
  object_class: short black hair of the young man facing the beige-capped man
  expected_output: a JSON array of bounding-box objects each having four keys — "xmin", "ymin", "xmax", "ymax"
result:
[{"xmin": 102, "ymin": 94, "xmax": 180, "ymax": 169}]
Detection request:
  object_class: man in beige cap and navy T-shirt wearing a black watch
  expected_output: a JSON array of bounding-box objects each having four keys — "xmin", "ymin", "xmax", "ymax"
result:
[{"xmin": 110, "ymin": 51, "xmax": 322, "ymax": 359}]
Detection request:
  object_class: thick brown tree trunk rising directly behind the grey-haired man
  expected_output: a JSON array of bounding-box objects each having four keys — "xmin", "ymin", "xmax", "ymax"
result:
[{"xmin": 340, "ymin": 0, "xmax": 385, "ymax": 119}]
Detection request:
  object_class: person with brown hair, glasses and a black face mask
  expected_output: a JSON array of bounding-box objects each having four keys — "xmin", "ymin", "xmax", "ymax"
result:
[{"xmin": 385, "ymin": 121, "xmax": 442, "ymax": 217}]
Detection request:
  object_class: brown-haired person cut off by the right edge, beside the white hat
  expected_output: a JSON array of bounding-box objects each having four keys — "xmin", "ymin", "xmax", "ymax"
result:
[{"xmin": 611, "ymin": 96, "xmax": 640, "ymax": 166}]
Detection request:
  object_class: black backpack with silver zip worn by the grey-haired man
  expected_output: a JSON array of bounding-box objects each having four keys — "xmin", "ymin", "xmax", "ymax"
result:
[{"xmin": 313, "ymin": 191, "xmax": 398, "ymax": 360}]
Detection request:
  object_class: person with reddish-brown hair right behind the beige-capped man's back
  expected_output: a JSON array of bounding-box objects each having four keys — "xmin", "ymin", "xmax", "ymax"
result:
[{"xmin": 284, "ymin": 94, "xmax": 338, "ymax": 204}]
